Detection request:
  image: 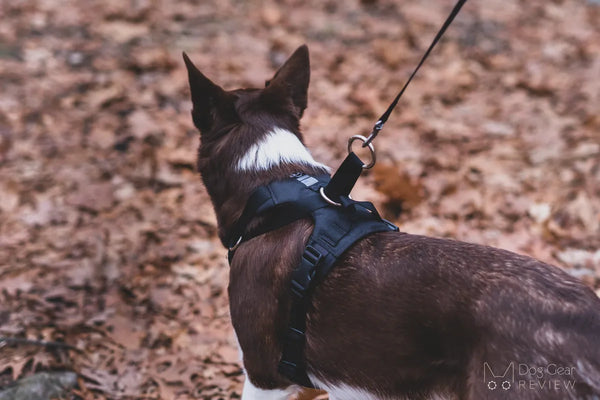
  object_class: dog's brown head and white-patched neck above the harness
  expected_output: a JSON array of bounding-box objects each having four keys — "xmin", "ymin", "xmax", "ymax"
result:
[{"xmin": 183, "ymin": 46, "xmax": 327, "ymax": 236}]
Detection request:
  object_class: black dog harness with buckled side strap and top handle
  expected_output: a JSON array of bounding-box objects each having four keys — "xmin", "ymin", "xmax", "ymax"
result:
[{"xmin": 223, "ymin": 156, "xmax": 398, "ymax": 387}]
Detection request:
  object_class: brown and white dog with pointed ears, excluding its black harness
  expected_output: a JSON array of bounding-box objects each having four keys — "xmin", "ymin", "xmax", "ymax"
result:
[{"xmin": 184, "ymin": 46, "xmax": 600, "ymax": 400}]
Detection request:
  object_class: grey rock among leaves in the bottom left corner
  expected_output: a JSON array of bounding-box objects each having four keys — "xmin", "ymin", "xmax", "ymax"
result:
[{"xmin": 0, "ymin": 372, "xmax": 77, "ymax": 400}]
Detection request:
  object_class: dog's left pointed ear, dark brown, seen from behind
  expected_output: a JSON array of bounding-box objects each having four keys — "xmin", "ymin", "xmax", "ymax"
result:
[{"xmin": 183, "ymin": 53, "xmax": 226, "ymax": 132}]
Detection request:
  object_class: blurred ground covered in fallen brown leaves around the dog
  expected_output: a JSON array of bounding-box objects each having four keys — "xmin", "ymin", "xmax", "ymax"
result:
[{"xmin": 0, "ymin": 0, "xmax": 600, "ymax": 399}]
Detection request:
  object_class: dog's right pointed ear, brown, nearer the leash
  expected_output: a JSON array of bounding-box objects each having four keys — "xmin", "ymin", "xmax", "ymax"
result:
[{"xmin": 263, "ymin": 45, "xmax": 310, "ymax": 117}]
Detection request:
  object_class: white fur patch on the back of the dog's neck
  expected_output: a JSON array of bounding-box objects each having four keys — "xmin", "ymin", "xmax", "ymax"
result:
[{"xmin": 236, "ymin": 128, "xmax": 329, "ymax": 171}]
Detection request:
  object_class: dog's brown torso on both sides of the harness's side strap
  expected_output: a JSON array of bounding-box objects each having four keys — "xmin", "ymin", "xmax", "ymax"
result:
[{"xmin": 230, "ymin": 223, "xmax": 600, "ymax": 400}]
